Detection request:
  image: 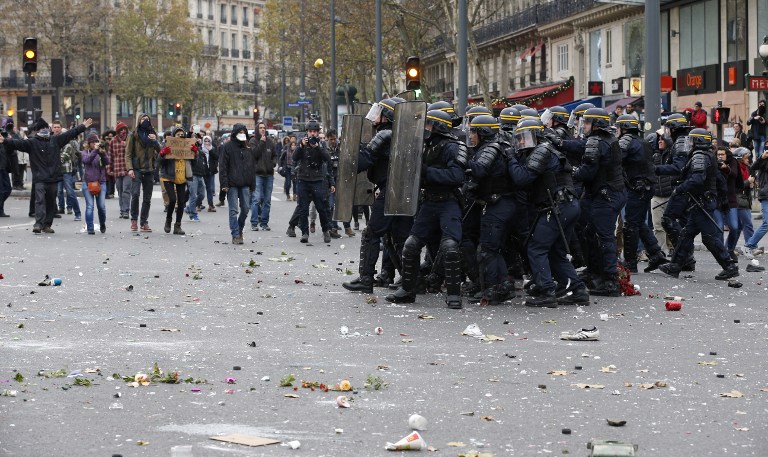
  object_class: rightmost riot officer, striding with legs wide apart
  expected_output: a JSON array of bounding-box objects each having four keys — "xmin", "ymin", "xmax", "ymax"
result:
[{"xmin": 659, "ymin": 129, "xmax": 739, "ymax": 280}]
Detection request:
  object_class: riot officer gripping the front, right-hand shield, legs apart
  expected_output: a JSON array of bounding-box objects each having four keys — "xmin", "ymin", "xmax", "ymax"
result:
[{"xmin": 385, "ymin": 110, "xmax": 467, "ymax": 309}]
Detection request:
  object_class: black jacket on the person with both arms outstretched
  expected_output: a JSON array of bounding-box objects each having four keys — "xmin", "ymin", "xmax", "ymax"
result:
[{"xmin": 4, "ymin": 124, "xmax": 85, "ymax": 183}]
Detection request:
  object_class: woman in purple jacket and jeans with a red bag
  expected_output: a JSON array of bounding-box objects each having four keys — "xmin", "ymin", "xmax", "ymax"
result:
[{"xmin": 82, "ymin": 132, "xmax": 109, "ymax": 235}]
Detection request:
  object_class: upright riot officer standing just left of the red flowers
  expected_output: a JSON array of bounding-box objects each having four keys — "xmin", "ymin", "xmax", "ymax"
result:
[{"xmin": 573, "ymin": 108, "xmax": 627, "ymax": 297}]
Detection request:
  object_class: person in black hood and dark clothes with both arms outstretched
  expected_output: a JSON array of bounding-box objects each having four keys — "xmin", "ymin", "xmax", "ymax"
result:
[{"xmin": 0, "ymin": 118, "xmax": 93, "ymax": 233}]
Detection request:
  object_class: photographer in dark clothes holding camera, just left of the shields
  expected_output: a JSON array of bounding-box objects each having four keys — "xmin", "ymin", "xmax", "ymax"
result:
[{"xmin": 293, "ymin": 120, "xmax": 336, "ymax": 243}]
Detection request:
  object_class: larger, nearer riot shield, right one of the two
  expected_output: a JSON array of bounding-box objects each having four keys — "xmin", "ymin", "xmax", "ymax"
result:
[{"xmin": 384, "ymin": 101, "xmax": 427, "ymax": 216}]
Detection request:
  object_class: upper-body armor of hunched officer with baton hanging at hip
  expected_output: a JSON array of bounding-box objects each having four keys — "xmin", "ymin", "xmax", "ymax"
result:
[{"xmin": 526, "ymin": 143, "xmax": 575, "ymax": 207}]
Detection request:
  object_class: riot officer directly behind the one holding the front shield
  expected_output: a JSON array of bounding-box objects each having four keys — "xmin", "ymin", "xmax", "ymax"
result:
[{"xmin": 469, "ymin": 114, "xmax": 515, "ymax": 305}]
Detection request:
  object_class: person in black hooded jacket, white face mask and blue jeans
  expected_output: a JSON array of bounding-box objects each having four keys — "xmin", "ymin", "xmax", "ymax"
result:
[{"xmin": 219, "ymin": 124, "xmax": 256, "ymax": 244}]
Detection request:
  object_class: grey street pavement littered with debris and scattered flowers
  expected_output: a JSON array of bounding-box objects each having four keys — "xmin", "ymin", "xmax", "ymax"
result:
[{"xmin": 0, "ymin": 178, "xmax": 768, "ymax": 457}]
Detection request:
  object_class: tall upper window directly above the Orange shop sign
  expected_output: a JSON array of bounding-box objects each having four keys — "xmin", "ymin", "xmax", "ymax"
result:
[{"xmin": 678, "ymin": 0, "xmax": 720, "ymax": 69}]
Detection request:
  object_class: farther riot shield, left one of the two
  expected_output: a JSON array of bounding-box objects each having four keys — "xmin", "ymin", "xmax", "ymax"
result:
[{"xmin": 333, "ymin": 114, "xmax": 364, "ymax": 222}]
